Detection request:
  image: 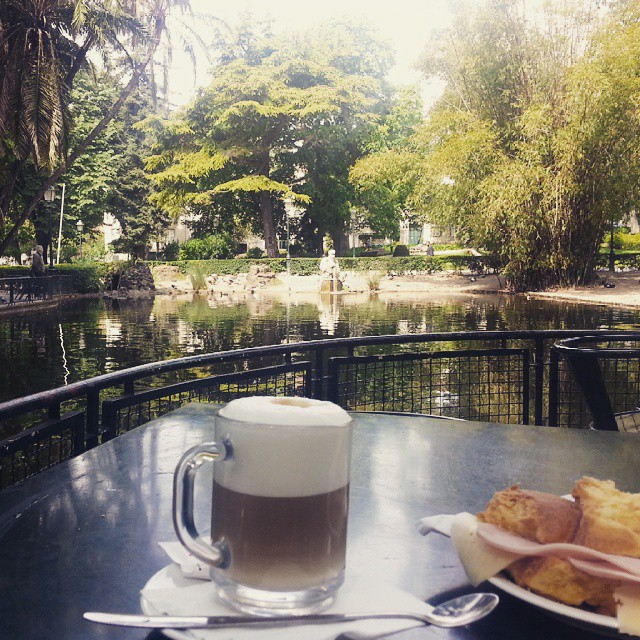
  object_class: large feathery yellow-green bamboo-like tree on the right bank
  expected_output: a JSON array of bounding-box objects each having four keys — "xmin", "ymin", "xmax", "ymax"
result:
[{"xmin": 400, "ymin": 0, "xmax": 640, "ymax": 290}]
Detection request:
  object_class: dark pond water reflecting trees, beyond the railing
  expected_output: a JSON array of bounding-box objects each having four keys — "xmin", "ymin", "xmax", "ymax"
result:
[{"xmin": 0, "ymin": 294, "xmax": 640, "ymax": 401}]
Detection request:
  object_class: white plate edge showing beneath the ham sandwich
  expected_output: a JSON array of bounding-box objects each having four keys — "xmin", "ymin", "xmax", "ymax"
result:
[{"xmin": 487, "ymin": 576, "xmax": 616, "ymax": 637}]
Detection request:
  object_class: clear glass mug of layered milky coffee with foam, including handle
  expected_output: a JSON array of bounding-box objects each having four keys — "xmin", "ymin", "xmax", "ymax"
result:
[{"xmin": 173, "ymin": 396, "xmax": 352, "ymax": 615}]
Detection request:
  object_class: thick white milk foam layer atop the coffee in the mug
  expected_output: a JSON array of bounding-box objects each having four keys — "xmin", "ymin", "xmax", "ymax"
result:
[{"xmin": 214, "ymin": 396, "xmax": 351, "ymax": 497}]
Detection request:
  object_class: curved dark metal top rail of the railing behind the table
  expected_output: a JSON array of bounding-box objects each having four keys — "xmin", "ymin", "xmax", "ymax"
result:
[{"xmin": 0, "ymin": 329, "xmax": 623, "ymax": 420}]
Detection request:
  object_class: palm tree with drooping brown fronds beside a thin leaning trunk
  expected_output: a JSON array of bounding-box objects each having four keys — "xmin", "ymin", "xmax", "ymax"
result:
[{"xmin": 0, "ymin": 0, "xmax": 188, "ymax": 255}]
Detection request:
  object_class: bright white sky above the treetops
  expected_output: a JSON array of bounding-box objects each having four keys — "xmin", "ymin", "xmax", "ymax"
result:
[{"xmin": 171, "ymin": 0, "xmax": 450, "ymax": 104}]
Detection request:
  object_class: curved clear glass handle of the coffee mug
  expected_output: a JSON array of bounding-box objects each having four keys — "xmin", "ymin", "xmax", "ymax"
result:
[{"xmin": 173, "ymin": 442, "xmax": 229, "ymax": 567}]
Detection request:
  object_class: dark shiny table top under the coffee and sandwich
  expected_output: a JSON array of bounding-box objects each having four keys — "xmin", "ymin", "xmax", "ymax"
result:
[{"xmin": 0, "ymin": 404, "xmax": 640, "ymax": 640}]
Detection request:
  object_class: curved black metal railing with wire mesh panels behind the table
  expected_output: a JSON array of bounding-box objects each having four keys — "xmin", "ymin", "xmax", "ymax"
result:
[{"xmin": 0, "ymin": 330, "xmax": 637, "ymax": 488}]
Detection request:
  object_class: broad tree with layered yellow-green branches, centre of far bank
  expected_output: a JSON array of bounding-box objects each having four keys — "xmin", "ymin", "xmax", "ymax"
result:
[{"xmin": 148, "ymin": 22, "xmax": 392, "ymax": 256}]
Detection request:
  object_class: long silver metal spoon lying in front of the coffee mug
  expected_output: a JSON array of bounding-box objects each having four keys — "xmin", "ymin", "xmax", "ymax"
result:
[{"xmin": 84, "ymin": 593, "xmax": 498, "ymax": 629}]
